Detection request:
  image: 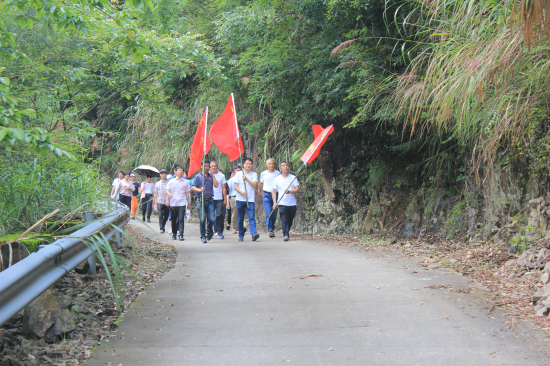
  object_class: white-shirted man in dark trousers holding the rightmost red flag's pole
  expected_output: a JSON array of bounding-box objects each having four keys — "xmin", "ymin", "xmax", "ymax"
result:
[{"xmin": 272, "ymin": 161, "xmax": 300, "ymax": 241}]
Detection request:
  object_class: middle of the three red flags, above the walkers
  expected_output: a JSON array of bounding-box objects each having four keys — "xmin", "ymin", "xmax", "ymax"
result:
[{"xmin": 210, "ymin": 93, "xmax": 244, "ymax": 161}]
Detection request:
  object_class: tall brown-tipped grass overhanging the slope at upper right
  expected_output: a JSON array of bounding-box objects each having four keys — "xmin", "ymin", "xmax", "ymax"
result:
[{"xmin": 362, "ymin": 0, "xmax": 550, "ymax": 166}]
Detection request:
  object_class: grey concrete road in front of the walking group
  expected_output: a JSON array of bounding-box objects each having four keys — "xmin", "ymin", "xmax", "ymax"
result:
[{"xmin": 87, "ymin": 221, "xmax": 550, "ymax": 366}]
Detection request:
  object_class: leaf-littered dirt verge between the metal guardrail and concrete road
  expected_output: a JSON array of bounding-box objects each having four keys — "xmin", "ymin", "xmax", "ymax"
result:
[{"xmin": 0, "ymin": 226, "xmax": 177, "ymax": 366}]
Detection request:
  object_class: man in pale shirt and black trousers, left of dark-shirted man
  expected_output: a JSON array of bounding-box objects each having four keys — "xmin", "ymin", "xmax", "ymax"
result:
[{"xmin": 166, "ymin": 165, "xmax": 191, "ymax": 241}]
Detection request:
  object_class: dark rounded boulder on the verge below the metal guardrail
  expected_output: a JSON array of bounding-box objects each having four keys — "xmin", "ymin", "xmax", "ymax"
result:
[{"xmin": 23, "ymin": 289, "xmax": 76, "ymax": 342}]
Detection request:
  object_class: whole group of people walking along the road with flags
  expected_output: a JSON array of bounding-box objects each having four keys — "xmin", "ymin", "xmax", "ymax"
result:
[{"xmin": 111, "ymin": 158, "xmax": 300, "ymax": 243}]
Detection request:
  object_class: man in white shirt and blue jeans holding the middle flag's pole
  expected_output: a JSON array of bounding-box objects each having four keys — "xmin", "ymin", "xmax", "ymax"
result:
[{"xmin": 234, "ymin": 158, "xmax": 260, "ymax": 241}]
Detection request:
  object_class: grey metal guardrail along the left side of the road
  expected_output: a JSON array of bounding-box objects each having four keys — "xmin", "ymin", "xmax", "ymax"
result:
[{"xmin": 0, "ymin": 205, "xmax": 130, "ymax": 325}]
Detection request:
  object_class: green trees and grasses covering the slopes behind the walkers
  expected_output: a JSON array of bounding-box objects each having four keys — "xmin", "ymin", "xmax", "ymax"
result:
[{"xmin": 0, "ymin": 0, "xmax": 550, "ymax": 240}]
